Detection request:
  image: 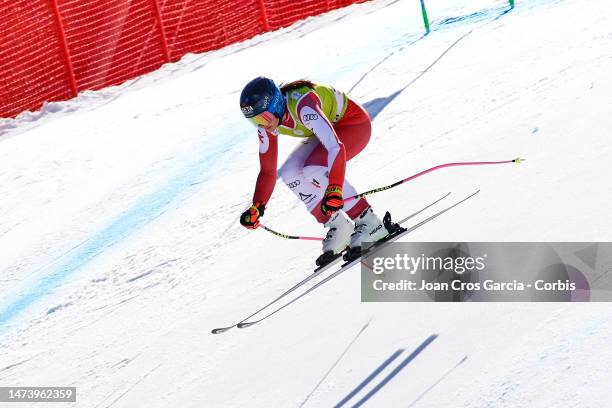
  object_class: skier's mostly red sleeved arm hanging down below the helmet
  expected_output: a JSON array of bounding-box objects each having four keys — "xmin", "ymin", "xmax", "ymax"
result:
[{"xmin": 253, "ymin": 127, "xmax": 278, "ymax": 204}]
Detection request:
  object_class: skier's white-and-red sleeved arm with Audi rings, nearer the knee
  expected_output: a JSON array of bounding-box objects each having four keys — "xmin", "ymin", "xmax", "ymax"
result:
[{"xmin": 297, "ymin": 92, "xmax": 346, "ymax": 186}]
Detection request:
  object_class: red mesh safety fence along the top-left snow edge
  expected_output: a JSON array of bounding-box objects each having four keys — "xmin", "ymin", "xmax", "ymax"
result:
[{"xmin": 0, "ymin": 0, "xmax": 365, "ymax": 117}]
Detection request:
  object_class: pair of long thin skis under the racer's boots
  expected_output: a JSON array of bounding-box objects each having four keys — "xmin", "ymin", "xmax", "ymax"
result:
[{"xmin": 212, "ymin": 190, "xmax": 480, "ymax": 334}]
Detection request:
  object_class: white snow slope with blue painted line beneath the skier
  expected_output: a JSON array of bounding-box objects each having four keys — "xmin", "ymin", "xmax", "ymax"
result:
[{"xmin": 0, "ymin": 0, "xmax": 612, "ymax": 407}]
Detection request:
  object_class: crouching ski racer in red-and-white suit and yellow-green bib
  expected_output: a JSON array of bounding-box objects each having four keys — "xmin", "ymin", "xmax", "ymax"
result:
[{"xmin": 240, "ymin": 77, "xmax": 388, "ymax": 265}]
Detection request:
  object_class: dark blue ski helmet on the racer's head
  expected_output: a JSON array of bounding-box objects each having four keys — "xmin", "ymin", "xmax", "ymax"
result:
[{"xmin": 240, "ymin": 77, "xmax": 285, "ymax": 119}]
